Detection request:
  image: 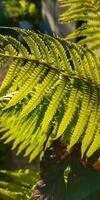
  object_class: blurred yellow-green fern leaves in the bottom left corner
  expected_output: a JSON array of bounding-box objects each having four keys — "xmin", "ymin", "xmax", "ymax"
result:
[{"xmin": 0, "ymin": 169, "xmax": 39, "ymax": 200}]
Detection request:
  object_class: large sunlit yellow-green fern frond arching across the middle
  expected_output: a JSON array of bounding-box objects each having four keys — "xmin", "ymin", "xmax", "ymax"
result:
[{"xmin": 0, "ymin": 28, "xmax": 100, "ymax": 161}]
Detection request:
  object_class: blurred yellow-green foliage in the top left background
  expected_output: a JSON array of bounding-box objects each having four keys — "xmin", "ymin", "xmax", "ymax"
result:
[{"xmin": 0, "ymin": 0, "xmax": 41, "ymax": 30}]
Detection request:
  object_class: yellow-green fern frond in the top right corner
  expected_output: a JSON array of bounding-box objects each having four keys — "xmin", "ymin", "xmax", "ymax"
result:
[{"xmin": 60, "ymin": 0, "xmax": 100, "ymax": 50}]
